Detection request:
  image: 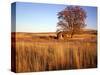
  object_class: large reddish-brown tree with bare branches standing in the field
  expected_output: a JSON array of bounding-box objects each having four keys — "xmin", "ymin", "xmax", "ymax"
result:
[{"xmin": 57, "ymin": 6, "xmax": 87, "ymax": 38}]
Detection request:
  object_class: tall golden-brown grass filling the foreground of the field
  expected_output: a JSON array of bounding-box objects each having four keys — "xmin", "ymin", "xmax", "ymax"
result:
[{"xmin": 12, "ymin": 40, "xmax": 97, "ymax": 72}]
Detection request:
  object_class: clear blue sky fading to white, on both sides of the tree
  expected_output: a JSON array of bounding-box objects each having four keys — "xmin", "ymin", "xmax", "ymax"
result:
[{"xmin": 12, "ymin": 2, "xmax": 97, "ymax": 32}]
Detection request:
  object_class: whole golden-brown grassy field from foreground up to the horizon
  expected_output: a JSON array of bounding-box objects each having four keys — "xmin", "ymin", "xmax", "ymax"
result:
[{"xmin": 12, "ymin": 30, "xmax": 97, "ymax": 72}]
